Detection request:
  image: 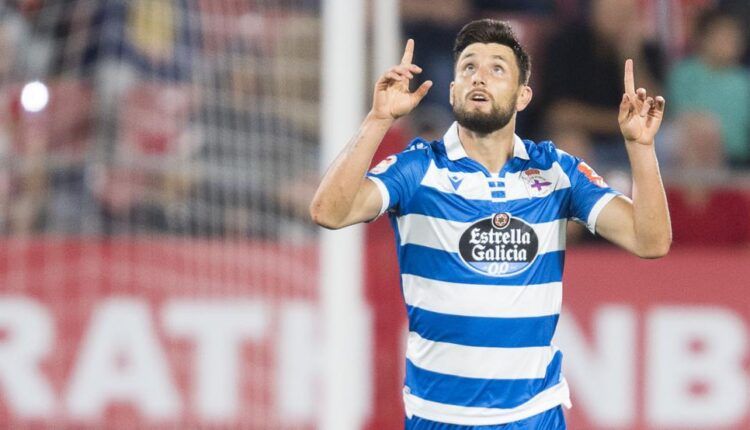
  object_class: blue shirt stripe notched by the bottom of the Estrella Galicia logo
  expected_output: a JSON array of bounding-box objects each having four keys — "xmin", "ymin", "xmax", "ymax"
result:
[{"xmin": 398, "ymin": 244, "xmax": 565, "ymax": 286}]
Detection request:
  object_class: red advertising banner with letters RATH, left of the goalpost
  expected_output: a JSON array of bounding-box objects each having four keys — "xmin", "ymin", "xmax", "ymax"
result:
[{"xmin": 0, "ymin": 237, "xmax": 317, "ymax": 429}]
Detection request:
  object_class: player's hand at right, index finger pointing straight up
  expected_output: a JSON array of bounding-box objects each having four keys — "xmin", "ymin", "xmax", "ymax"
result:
[{"xmin": 617, "ymin": 60, "xmax": 665, "ymax": 145}]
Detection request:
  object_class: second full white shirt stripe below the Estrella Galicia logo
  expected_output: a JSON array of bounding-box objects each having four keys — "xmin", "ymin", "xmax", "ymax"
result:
[{"xmin": 406, "ymin": 332, "xmax": 557, "ymax": 379}]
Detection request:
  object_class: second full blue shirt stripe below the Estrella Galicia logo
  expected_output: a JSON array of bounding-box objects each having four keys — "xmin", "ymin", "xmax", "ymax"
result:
[{"xmin": 406, "ymin": 305, "xmax": 559, "ymax": 348}]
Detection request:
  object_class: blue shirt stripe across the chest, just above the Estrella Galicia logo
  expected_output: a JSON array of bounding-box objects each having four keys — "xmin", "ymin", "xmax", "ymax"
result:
[{"xmin": 401, "ymin": 186, "xmax": 570, "ymax": 224}]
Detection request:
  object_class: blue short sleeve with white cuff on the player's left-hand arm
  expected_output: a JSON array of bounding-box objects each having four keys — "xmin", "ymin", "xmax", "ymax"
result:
[{"xmin": 367, "ymin": 140, "xmax": 430, "ymax": 216}]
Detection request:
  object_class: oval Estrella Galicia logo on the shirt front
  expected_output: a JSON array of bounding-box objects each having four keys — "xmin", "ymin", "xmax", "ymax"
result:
[{"xmin": 458, "ymin": 212, "xmax": 539, "ymax": 277}]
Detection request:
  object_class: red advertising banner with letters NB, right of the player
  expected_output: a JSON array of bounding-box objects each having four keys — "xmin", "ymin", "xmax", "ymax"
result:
[{"xmin": 557, "ymin": 247, "xmax": 750, "ymax": 429}]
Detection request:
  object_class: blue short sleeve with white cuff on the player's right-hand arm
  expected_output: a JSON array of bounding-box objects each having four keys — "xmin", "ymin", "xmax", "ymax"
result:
[{"xmin": 565, "ymin": 154, "xmax": 621, "ymax": 233}]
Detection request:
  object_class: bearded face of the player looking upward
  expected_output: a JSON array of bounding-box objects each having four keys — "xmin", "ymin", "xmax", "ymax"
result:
[{"xmin": 451, "ymin": 43, "xmax": 527, "ymax": 134}]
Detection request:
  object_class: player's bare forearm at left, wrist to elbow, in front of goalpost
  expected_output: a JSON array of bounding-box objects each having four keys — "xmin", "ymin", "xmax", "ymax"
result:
[{"xmin": 310, "ymin": 114, "xmax": 393, "ymax": 226}]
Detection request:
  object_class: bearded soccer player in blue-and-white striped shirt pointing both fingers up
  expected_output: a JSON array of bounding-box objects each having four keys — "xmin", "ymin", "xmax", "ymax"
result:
[{"xmin": 310, "ymin": 20, "xmax": 671, "ymax": 430}]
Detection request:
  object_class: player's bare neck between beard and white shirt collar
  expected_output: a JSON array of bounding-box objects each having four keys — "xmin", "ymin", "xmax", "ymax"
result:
[{"xmin": 458, "ymin": 118, "xmax": 516, "ymax": 173}]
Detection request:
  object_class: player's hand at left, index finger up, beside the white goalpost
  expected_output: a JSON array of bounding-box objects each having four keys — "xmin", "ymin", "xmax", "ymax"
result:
[{"xmin": 370, "ymin": 39, "xmax": 432, "ymax": 120}]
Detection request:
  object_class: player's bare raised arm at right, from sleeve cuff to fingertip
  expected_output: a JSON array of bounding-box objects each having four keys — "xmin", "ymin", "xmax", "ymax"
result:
[{"xmin": 596, "ymin": 60, "xmax": 672, "ymax": 258}]
